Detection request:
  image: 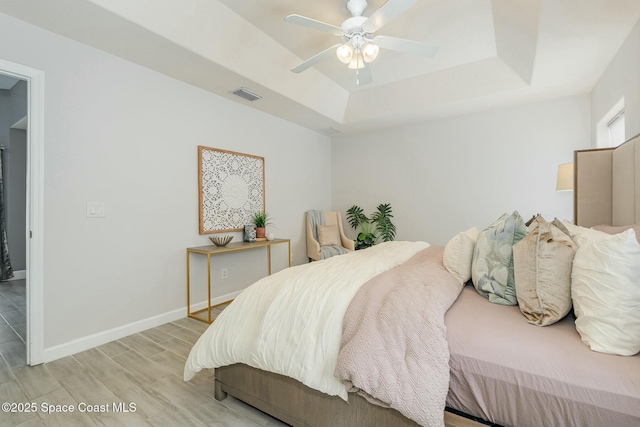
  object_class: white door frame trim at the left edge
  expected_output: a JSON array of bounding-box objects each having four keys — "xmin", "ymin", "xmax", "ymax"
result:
[{"xmin": 0, "ymin": 59, "xmax": 44, "ymax": 366}]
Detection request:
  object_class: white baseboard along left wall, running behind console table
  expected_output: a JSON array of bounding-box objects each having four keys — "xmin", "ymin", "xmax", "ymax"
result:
[{"xmin": 43, "ymin": 291, "xmax": 241, "ymax": 363}]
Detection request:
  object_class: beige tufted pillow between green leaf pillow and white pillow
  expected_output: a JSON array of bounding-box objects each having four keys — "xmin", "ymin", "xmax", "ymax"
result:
[{"xmin": 513, "ymin": 217, "xmax": 577, "ymax": 326}]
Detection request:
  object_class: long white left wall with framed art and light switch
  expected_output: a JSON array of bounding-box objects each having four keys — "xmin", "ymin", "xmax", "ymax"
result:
[{"xmin": 0, "ymin": 14, "xmax": 331, "ymax": 357}]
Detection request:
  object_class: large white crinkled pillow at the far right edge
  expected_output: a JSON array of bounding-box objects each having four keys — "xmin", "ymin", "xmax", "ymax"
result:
[{"xmin": 571, "ymin": 229, "xmax": 640, "ymax": 356}]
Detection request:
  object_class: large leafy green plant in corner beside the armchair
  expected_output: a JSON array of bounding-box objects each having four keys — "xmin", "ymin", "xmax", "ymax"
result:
[{"xmin": 347, "ymin": 203, "xmax": 396, "ymax": 250}]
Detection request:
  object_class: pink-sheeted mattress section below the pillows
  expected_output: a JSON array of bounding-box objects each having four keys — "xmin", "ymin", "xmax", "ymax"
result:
[{"xmin": 445, "ymin": 286, "xmax": 640, "ymax": 427}]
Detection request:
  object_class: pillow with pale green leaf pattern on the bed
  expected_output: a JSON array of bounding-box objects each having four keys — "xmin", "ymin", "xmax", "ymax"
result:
[{"xmin": 471, "ymin": 211, "xmax": 528, "ymax": 305}]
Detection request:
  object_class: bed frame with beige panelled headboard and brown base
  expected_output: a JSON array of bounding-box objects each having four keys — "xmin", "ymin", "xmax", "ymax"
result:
[{"xmin": 215, "ymin": 135, "xmax": 640, "ymax": 427}]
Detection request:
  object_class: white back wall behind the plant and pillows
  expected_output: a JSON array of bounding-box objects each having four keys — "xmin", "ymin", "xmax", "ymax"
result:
[{"xmin": 332, "ymin": 95, "xmax": 590, "ymax": 245}]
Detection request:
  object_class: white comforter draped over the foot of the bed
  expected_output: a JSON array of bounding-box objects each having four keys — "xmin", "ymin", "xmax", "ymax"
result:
[{"xmin": 184, "ymin": 242, "xmax": 429, "ymax": 400}]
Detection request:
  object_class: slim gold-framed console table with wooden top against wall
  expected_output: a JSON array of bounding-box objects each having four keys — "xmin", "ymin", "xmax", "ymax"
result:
[{"xmin": 187, "ymin": 239, "xmax": 291, "ymax": 323}]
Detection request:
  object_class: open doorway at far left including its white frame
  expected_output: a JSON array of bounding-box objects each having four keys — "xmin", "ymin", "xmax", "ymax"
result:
[{"xmin": 0, "ymin": 59, "xmax": 44, "ymax": 365}]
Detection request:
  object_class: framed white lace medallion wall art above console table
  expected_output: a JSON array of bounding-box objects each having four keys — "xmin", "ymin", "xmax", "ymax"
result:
[{"xmin": 198, "ymin": 146, "xmax": 265, "ymax": 234}]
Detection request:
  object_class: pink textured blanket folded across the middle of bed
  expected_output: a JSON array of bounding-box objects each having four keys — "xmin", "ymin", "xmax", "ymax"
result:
[{"xmin": 334, "ymin": 246, "xmax": 462, "ymax": 426}]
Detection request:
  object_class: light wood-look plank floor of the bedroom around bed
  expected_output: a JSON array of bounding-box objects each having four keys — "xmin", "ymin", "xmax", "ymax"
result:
[{"xmin": 0, "ymin": 300, "xmax": 478, "ymax": 427}]
